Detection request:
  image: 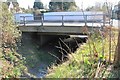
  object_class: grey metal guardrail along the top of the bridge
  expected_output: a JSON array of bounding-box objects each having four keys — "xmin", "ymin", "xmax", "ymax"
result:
[{"xmin": 20, "ymin": 14, "xmax": 106, "ymax": 26}]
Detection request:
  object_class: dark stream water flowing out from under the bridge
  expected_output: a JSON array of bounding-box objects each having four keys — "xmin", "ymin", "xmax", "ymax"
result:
[{"xmin": 18, "ymin": 33, "xmax": 57, "ymax": 78}]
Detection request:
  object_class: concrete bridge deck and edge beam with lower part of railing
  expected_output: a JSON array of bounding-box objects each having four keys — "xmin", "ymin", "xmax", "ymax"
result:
[{"xmin": 18, "ymin": 14, "xmax": 107, "ymax": 35}]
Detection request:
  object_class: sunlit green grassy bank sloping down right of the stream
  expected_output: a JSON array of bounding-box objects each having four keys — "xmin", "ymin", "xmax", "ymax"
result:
[{"xmin": 46, "ymin": 27, "xmax": 119, "ymax": 78}]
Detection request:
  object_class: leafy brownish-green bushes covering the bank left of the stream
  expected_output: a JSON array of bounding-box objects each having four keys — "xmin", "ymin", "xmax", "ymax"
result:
[{"xmin": 0, "ymin": 3, "xmax": 26, "ymax": 78}]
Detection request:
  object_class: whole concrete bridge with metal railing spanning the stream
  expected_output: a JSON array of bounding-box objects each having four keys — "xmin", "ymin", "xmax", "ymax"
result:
[{"xmin": 17, "ymin": 12, "xmax": 108, "ymax": 46}]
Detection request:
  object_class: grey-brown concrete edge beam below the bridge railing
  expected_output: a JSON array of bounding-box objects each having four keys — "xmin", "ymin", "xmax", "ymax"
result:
[{"xmin": 19, "ymin": 26, "xmax": 100, "ymax": 35}]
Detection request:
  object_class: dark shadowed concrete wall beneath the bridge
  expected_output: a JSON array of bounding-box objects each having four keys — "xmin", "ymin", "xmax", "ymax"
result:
[{"xmin": 22, "ymin": 32, "xmax": 68, "ymax": 47}]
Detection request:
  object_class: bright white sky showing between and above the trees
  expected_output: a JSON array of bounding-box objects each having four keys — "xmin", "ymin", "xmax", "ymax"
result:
[{"xmin": 4, "ymin": 0, "xmax": 120, "ymax": 8}]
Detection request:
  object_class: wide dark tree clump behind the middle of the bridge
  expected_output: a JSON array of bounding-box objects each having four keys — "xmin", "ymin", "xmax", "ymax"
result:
[{"xmin": 49, "ymin": 0, "xmax": 78, "ymax": 11}]
